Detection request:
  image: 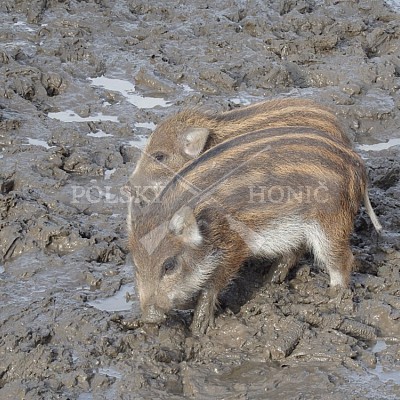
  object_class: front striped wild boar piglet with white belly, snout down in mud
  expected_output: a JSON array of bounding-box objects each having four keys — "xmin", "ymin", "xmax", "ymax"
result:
[{"xmin": 128, "ymin": 127, "xmax": 366, "ymax": 332}]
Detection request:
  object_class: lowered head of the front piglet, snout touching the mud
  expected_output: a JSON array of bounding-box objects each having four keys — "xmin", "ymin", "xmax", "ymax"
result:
[{"xmin": 129, "ymin": 204, "xmax": 217, "ymax": 323}]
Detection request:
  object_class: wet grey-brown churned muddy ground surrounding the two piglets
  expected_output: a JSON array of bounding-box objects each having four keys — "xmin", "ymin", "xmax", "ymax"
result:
[{"xmin": 0, "ymin": 0, "xmax": 400, "ymax": 400}]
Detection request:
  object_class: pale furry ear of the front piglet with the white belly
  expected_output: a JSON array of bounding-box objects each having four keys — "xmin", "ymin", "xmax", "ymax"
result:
[{"xmin": 169, "ymin": 206, "xmax": 203, "ymax": 246}]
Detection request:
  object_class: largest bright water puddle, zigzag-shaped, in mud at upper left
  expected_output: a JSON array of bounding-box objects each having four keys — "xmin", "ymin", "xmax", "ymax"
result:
[{"xmin": 89, "ymin": 76, "xmax": 171, "ymax": 108}]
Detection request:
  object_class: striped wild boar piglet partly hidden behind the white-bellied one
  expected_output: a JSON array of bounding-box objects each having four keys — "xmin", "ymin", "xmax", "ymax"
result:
[{"xmin": 129, "ymin": 98, "xmax": 350, "ymax": 189}]
